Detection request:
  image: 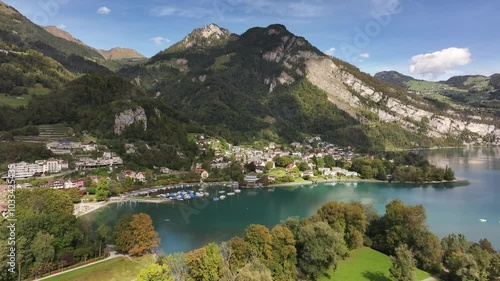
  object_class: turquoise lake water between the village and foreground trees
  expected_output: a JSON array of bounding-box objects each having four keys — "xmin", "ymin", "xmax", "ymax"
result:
[{"xmin": 87, "ymin": 148, "xmax": 500, "ymax": 253}]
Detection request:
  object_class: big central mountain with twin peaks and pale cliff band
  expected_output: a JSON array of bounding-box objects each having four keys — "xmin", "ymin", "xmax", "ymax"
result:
[{"xmin": 120, "ymin": 24, "xmax": 500, "ymax": 149}]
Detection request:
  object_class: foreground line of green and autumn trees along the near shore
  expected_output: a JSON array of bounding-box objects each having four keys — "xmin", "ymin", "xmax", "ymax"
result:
[{"xmin": 137, "ymin": 200, "xmax": 500, "ymax": 281}]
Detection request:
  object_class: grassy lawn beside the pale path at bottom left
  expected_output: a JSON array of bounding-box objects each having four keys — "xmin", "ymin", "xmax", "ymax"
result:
[{"xmin": 46, "ymin": 255, "xmax": 154, "ymax": 281}]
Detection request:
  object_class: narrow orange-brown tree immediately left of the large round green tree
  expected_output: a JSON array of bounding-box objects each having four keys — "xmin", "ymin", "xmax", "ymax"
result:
[{"xmin": 269, "ymin": 225, "xmax": 297, "ymax": 281}]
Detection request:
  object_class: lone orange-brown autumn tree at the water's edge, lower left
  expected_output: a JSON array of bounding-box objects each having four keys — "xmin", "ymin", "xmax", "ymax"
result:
[{"xmin": 115, "ymin": 213, "xmax": 160, "ymax": 256}]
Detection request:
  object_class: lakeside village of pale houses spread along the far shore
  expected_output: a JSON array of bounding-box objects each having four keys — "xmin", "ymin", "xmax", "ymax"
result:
[{"xmin": 3, "ymin": 135, "xmax": 358, "ymax": 189}]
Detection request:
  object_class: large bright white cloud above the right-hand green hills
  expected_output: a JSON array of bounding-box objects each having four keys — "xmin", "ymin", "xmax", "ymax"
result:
[{"xmin": 410, "ymin": 48, "xmax": 471, "ymax": 78}]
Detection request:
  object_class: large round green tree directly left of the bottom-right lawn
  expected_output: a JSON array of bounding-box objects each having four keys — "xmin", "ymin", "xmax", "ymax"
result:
[{"xmin": 297, "ymin": 222, "xmax": 347, "ymax": 279}]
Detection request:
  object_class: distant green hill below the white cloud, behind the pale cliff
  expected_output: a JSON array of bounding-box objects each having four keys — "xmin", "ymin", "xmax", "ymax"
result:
[{"xmin": 375, "ymin": 71, "xmax": 500, "ymax": 117}]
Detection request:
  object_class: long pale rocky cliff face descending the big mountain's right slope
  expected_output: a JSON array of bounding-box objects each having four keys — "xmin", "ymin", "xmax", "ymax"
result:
[{"xmin": 306, "ymin": 58, "xmax": 500, "ymax": 144}]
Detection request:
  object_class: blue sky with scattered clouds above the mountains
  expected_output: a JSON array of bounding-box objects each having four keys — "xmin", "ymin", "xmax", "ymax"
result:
[{"xmin": 4, "ymin": 0, "xmax": 500, "ymax": 80}]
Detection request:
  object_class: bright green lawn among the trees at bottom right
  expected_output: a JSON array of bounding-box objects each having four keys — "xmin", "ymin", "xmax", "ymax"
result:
[{"xmin": 319, "ymin": 248, "xmax": 431, "ymax": 281}]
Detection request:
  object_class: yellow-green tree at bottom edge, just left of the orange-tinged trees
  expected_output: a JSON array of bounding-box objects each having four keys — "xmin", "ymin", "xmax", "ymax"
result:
[{"xmin": 186, "ymin": 243, "xmax": 222, "ymax": 281}]
